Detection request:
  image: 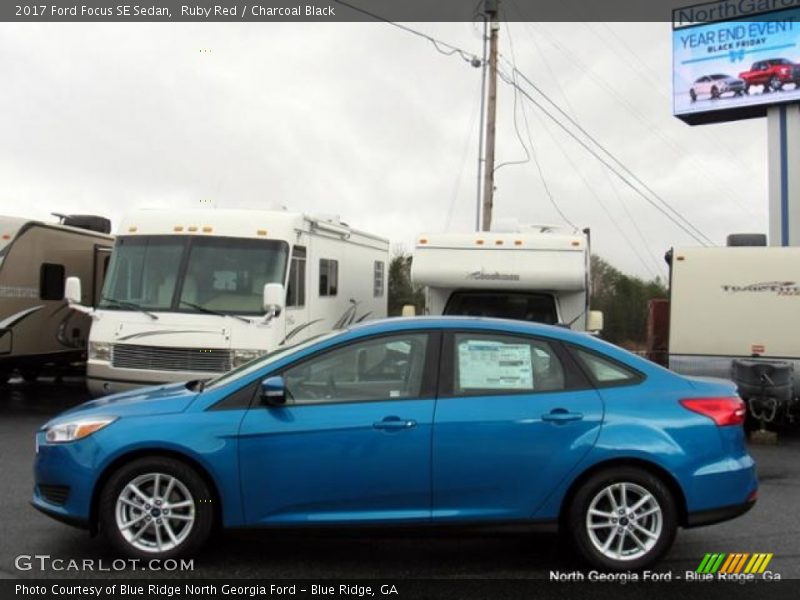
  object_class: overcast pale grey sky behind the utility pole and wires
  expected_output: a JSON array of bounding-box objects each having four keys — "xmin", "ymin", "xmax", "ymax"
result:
[{"xmin": 0, "ymin": 23, "xmax": 767, "ymax": 278}]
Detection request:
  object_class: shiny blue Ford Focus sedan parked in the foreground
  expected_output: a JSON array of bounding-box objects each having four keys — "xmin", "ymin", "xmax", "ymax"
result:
[{"xmin": 33, "ymin": 318, "xmax": 757, "ymax": 569}]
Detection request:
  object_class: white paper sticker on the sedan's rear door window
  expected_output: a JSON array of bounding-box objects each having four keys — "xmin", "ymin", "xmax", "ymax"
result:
[{"xmin": 458, "ymin": 340, "xmax": 533, "ymax": 390}]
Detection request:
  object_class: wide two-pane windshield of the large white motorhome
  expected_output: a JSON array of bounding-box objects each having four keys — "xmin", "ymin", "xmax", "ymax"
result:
[{"xmin": 100, "ymin": 235, "xmax": 288, "ymax": 315}]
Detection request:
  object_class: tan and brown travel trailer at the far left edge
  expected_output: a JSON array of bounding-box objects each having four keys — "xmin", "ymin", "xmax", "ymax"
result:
[{"xmin": 0, "ymin": 215, "xmax": 114, "ymax": 383}]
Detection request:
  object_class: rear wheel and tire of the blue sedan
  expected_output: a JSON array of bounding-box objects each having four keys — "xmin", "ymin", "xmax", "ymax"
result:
[{"xmin": 567, "ymin": 467, "xmax": 678, "ymax": 571}]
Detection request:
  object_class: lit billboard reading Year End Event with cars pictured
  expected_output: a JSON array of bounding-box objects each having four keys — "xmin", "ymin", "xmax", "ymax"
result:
[{"xmin": 672, "ymin": 2, "xmax": 800, "ymax": 125}]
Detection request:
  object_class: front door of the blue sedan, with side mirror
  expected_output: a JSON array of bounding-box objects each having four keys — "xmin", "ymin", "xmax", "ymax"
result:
[{"xmin": 239, "ymin": 331, "xmax": 440, "ymax": 524}]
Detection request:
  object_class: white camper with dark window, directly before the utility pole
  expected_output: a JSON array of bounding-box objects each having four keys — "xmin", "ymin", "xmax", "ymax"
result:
[{"xmin": 411, "ymin": 226, "xmax": 602, "ymax": 331}]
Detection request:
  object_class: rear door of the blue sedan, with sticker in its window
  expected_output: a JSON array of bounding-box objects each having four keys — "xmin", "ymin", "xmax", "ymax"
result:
[{"xmin": 432, "ymin": 331, "xmax": 603, "ymax": 521}]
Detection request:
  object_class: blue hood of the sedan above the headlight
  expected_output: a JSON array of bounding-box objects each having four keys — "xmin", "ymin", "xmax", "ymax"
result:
[{"xmin": 44, "ymin": 383, "xmax": 198, "ymax": 427}]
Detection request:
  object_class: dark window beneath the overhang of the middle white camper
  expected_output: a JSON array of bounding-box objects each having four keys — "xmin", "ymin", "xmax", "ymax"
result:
[{"xmin": 444, "ymin": 291, "xmax": 558, "ymax": 325}]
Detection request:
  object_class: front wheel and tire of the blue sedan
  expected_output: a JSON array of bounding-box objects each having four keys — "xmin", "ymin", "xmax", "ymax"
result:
[{"xmin": 98, "ymin": 456, "xmax": 214, "ymax": 560}]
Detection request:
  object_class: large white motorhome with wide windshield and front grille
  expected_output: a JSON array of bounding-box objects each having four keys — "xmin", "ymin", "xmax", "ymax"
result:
[{"xmin": 70, "ymin": 209, "xmax": 389, "ymax": 396}]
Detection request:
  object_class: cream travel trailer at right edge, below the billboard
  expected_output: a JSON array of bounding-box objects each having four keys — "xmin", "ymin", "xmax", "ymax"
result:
[{"xmin": 668, "ymin": 240, "xmax": 800, "ymax": 422}]
